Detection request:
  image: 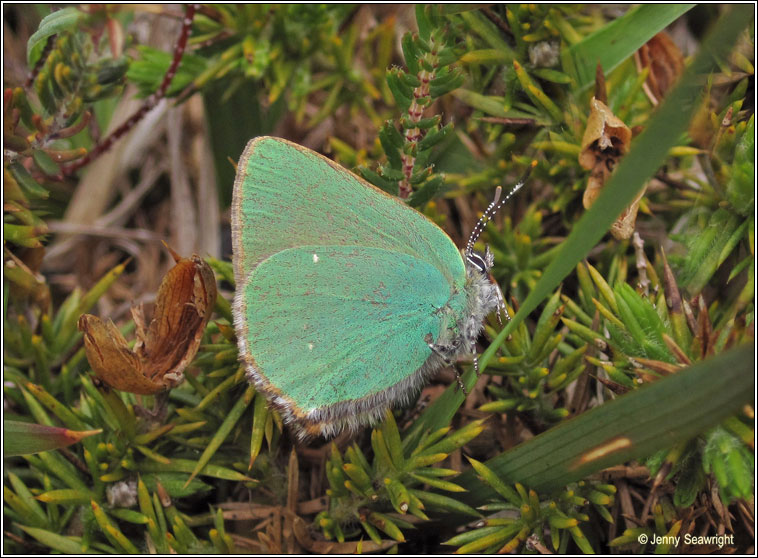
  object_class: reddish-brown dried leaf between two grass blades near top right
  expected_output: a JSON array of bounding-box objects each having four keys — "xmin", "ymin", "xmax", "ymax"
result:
[{"xmin": 634, "ymin": 31, "xmax": 684, "ymax": 105}]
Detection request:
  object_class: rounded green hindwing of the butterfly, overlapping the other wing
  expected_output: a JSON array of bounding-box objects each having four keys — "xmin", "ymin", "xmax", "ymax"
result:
[{"xmin": 243, "ymin": 246, "xmax": 457, "ymax": 413}]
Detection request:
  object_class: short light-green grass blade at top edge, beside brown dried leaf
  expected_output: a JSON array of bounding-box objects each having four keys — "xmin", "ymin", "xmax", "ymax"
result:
[{"xmin": 563, "ymin": 4, "xmax": 695, "ymax": 91}]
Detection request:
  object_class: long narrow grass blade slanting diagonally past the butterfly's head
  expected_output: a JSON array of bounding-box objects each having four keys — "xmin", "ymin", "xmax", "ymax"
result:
[{"xmin": 408, "ymin": 5, "xmax": 753, "ymax": 442}]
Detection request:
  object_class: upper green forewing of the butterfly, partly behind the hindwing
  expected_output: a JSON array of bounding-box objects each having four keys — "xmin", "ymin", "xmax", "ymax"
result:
[{"xmin": 231, "ymin": 137, "xmax": 465, "ymax": 286}]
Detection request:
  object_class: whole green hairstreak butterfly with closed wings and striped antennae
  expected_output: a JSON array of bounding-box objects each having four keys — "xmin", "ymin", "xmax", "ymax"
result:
[{"xmin": 231, "ymin": 137, "xmax": 523, "ymax": 438}]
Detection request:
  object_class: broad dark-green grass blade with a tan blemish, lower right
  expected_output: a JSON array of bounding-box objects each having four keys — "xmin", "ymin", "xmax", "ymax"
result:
[{"xmin": 456, "ymin": 345, "xmax": 755, "ymax": 504}]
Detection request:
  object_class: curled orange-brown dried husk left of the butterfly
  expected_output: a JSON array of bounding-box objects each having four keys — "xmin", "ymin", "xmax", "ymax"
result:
[{"xmin": 79, "ymin": 249, "xmax": 217, "ymax": 395}]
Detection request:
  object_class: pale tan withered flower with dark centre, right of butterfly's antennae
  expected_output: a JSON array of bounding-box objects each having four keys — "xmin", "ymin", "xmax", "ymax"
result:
[{"xmin": 579, "ymin": 97, "xmax": 645, "ymax": 240}]
